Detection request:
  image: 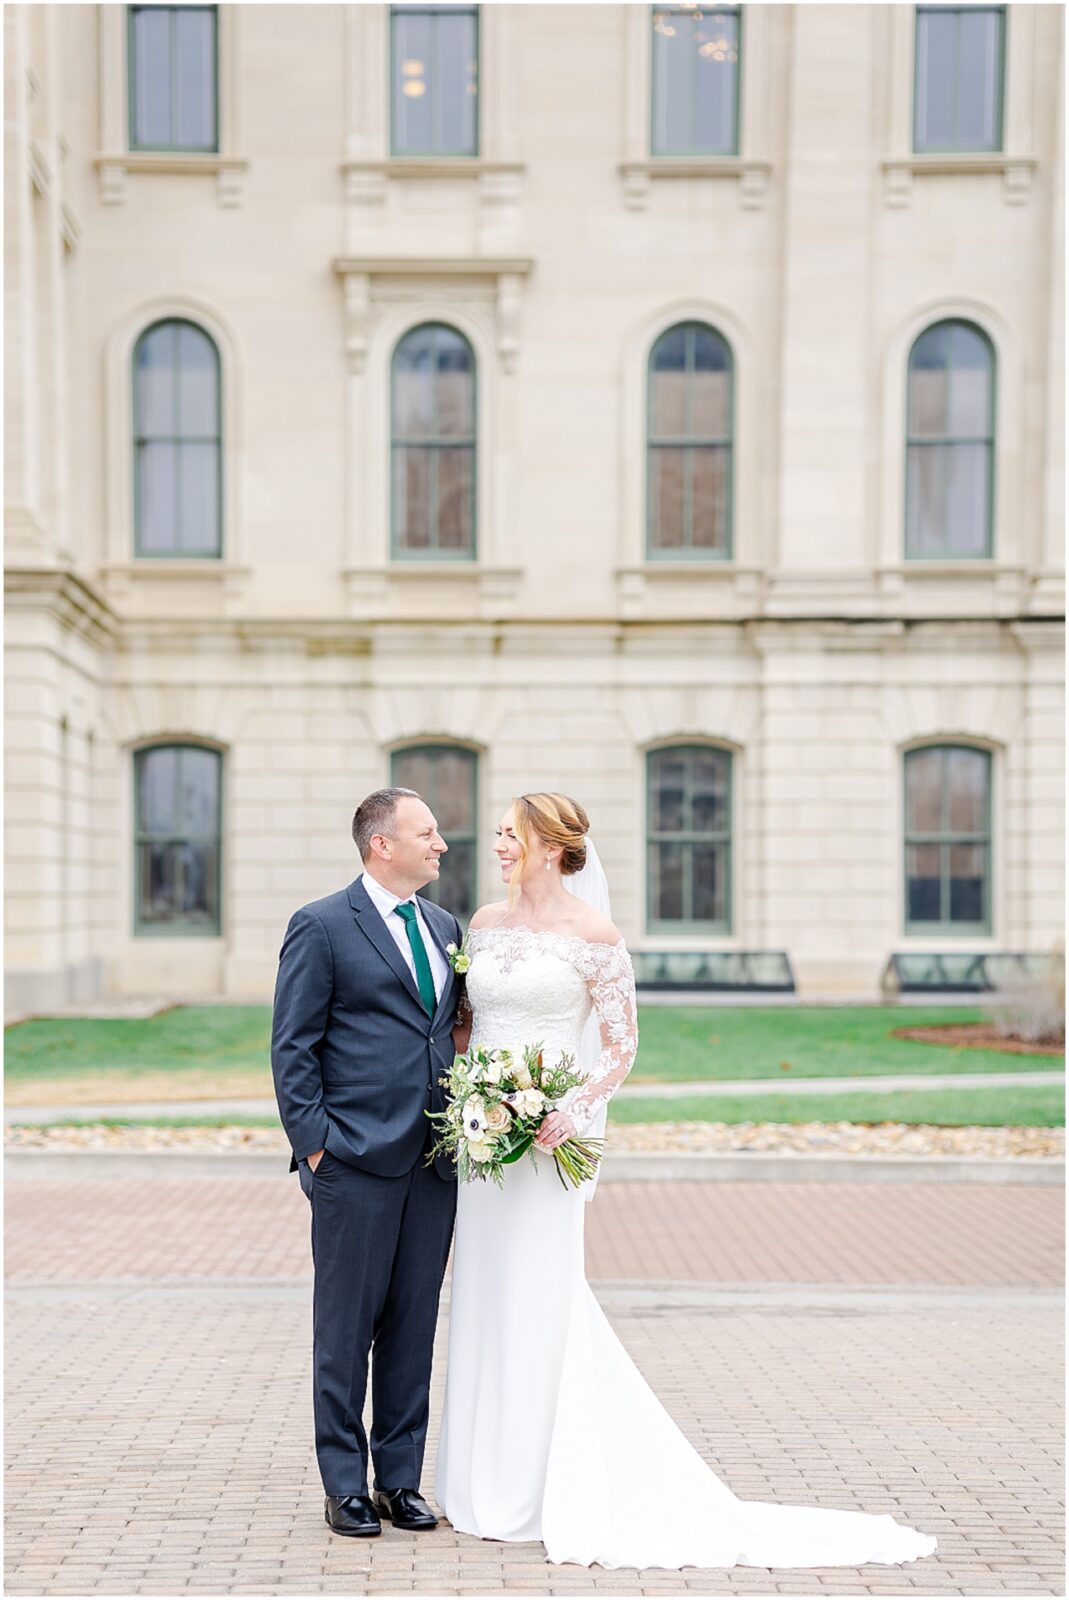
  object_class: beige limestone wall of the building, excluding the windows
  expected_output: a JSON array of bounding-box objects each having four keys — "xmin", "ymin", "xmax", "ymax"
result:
[{"xmin": 5, "ymin": 5, "xmax": 1064, "ymax": 1006}]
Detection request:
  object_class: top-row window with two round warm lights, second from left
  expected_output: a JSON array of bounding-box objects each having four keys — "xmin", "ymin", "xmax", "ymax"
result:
[{"xmin": 390, "ymin": 6, "xmax": 478, "ymax": 155}]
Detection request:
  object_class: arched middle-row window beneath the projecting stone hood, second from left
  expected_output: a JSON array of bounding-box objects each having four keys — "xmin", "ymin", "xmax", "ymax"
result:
[{"xmin": 390, "ymin": 323, "xmax": 475, "ymax": 560}]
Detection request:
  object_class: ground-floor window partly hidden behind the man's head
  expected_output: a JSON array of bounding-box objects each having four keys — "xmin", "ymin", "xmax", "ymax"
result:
[{"xmin": 390, "ymin": 744, "xmax": 478, "ymax": 923}]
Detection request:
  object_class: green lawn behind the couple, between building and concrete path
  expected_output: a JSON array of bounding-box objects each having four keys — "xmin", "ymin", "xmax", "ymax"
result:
[{"xmin": 5, "ymin": 1006, "xmax": 1064, "ymax": 1115}]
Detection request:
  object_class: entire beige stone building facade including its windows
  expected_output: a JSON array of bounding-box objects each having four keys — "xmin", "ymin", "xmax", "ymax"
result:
[{"xmin": 5, "ymin": 3, "xmax": 1064, "ymax": 1010}]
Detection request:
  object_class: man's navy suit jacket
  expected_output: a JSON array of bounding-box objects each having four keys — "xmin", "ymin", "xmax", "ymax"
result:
[{"xmin": 270, "ymin": 878, "xmax": 462, "ymax": 1179}]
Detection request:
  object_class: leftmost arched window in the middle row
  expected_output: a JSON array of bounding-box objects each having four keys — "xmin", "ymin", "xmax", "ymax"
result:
[{"xmin": 133, "ymin": 320, "xmax": 222, "ymax": 557}]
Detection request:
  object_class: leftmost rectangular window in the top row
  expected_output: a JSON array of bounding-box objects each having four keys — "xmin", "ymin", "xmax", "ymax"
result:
[{"xmin": 126, "ymin": 5, "xmax": 219, "ymax": 154}]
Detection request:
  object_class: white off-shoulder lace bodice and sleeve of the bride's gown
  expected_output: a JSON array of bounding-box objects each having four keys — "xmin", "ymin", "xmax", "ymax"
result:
[{"xmin": 467, "ymin": 928, "xmax": 639, "ymax": 1128}]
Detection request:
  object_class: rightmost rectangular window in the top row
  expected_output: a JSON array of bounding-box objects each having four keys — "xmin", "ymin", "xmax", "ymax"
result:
[{"xmin": 914, "ymin": 6, "xmax": 1007, "ymax": 155}]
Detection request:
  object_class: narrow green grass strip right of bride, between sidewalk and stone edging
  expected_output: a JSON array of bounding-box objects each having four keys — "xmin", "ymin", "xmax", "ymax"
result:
[{"xmin": 610, "ymin": 1083, "xmax": 1066, "ymax": 1128}]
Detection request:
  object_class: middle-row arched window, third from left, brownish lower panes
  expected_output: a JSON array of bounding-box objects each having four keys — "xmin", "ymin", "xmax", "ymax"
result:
[{"xmin": 647, "ymin": 322, "xmax": 733, "ymax": 560}]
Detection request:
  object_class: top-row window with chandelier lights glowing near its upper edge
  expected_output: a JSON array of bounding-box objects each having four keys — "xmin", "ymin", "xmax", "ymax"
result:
[{"xmin": 651, "ymin": 6, "xmax": 741, "ymax": 155}]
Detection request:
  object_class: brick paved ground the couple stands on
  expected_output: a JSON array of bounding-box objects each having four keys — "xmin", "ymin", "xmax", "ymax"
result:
[{"xmin": 6, "ymin": 1173, "xmax": 1064, "ymax": 1595}]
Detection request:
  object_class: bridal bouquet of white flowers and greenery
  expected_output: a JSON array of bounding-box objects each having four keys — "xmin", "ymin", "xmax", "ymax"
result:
[{"xmin": 427, "ymin": 1045, "xmax": 605, "ymax": 1189}]
